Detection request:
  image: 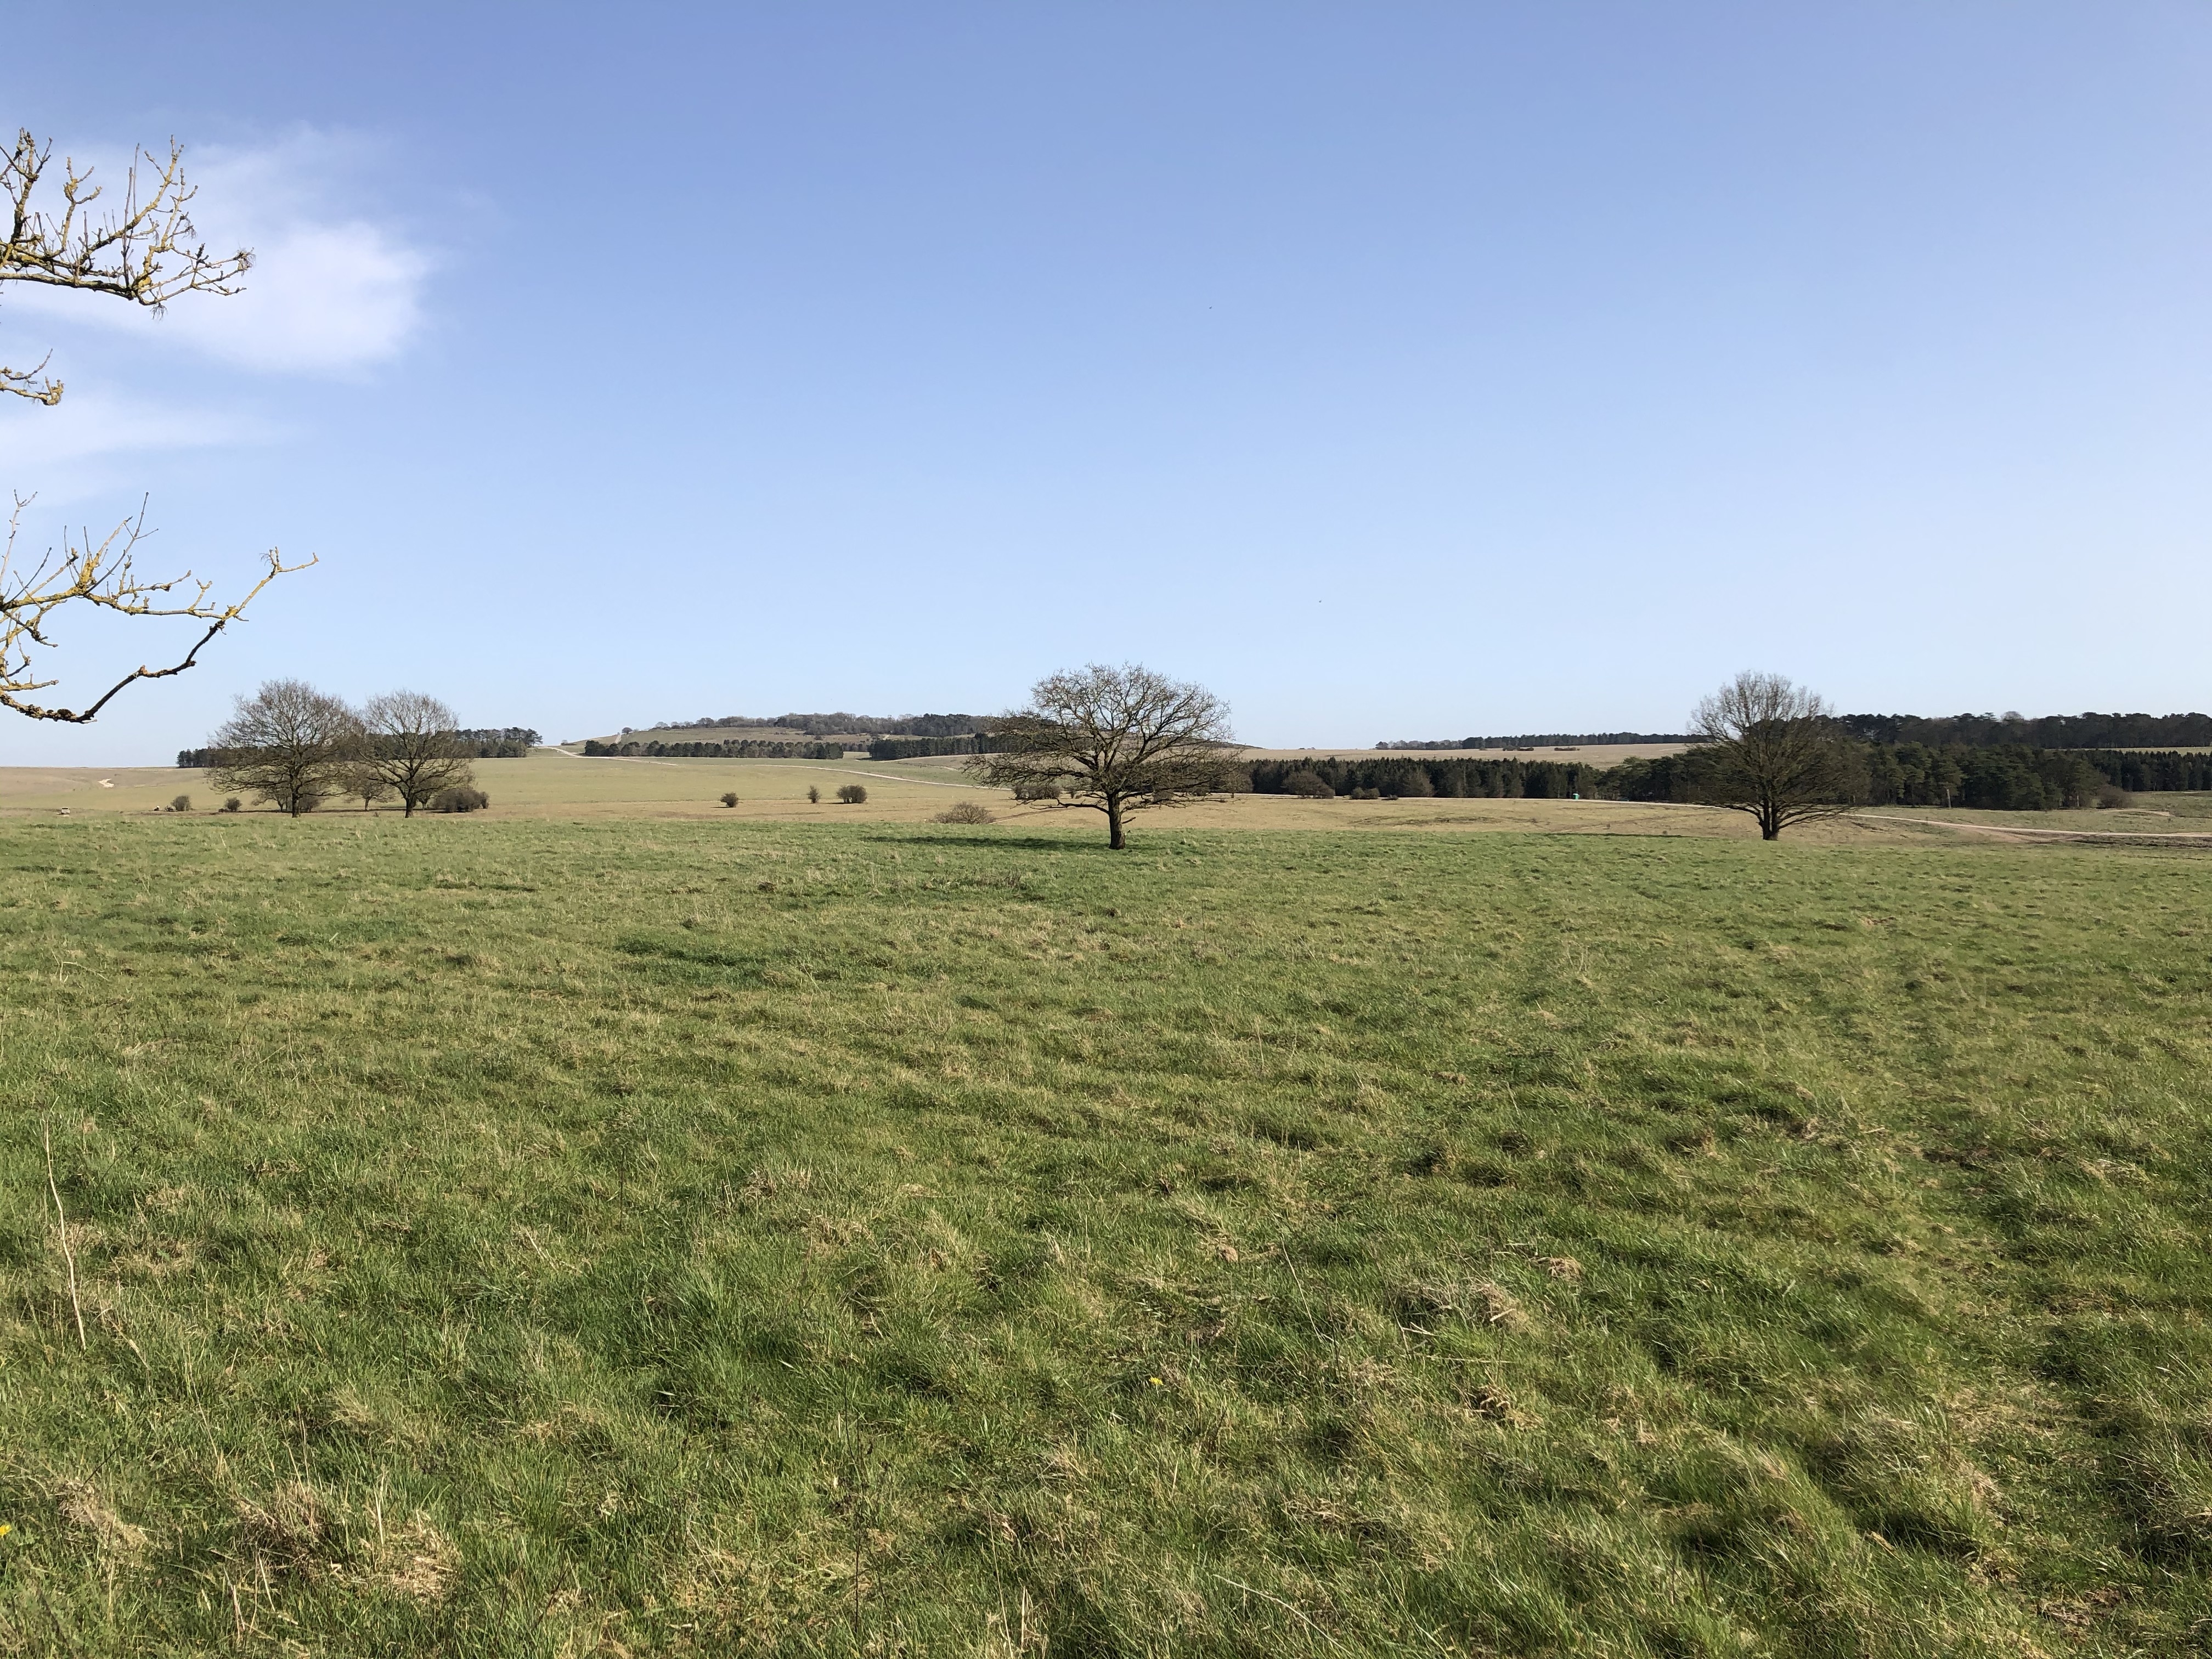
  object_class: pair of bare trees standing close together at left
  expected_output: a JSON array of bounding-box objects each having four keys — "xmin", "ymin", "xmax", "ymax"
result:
[{"xmin": 208, "ymin": 679, "xmax": 489, "ymax": 819}]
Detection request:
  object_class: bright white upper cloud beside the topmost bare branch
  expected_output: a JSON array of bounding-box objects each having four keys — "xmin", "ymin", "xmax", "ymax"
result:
[{"xmin": 7, "ymin": 133, "xmax": 433, "ymax": 376}]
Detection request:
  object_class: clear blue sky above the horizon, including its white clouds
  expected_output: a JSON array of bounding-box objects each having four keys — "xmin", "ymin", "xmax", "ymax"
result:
[{"xmin": 0, "ymin": 2, "xmax": 2212, "ymax": 765}]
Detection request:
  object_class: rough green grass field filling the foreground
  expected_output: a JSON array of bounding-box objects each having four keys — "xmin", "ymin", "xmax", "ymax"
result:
[{"xmin": 0, "ymin": 819, "xmax": 2212, "ymax": 1657}]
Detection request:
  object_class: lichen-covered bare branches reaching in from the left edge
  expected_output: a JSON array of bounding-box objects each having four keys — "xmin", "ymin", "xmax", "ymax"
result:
[{"xmin": 0, "ymin": 133, "xmax": 314, "ymax": 725}]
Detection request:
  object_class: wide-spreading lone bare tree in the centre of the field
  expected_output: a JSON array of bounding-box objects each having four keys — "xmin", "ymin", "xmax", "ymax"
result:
[{"xmin": 967, "ymin": 664, "xmax": 1237, "ymax": 847}]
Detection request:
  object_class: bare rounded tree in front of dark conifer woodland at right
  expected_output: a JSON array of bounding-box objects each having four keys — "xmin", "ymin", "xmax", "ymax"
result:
[{"xmin": 1692, "ymin": 673, "xmax": 1852, "ymax": 840}]
